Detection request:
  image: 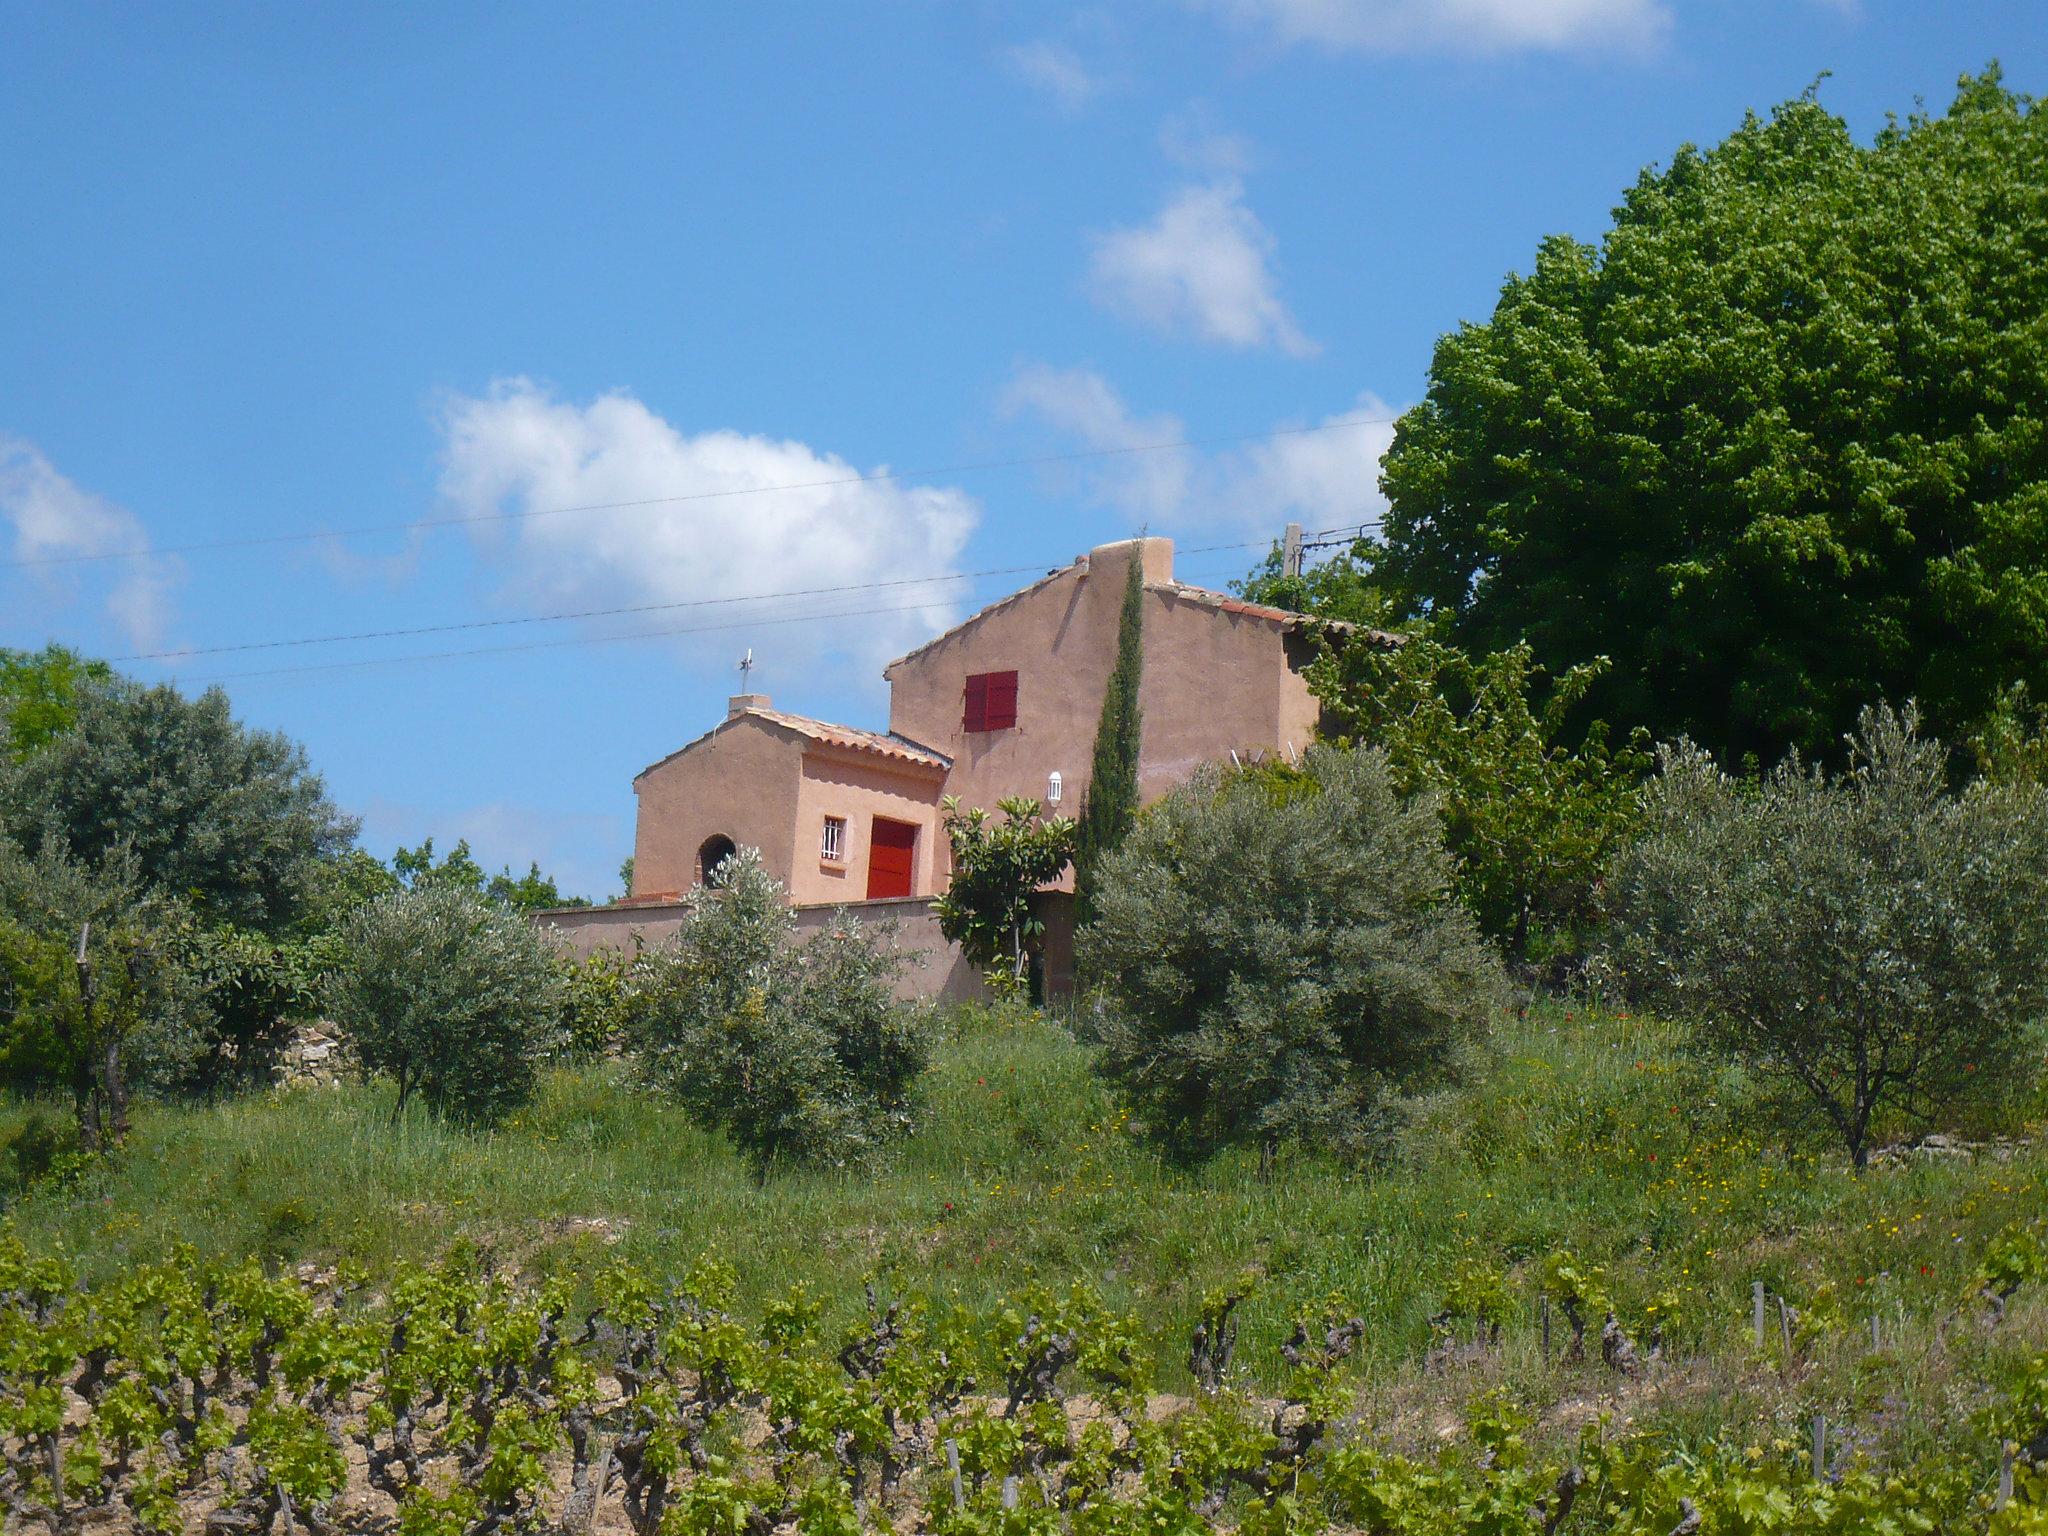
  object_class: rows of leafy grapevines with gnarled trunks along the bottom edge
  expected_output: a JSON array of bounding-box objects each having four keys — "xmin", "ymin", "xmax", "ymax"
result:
[{"xmin": 0, "ymin": 1229, "xmax": 2048, "ymax": 1536}]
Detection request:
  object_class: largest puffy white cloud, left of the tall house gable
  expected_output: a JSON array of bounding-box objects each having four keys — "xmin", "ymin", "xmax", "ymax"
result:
[{"xmin": 440, "ymin": 379, "xmax": 977, "ymax": 688}]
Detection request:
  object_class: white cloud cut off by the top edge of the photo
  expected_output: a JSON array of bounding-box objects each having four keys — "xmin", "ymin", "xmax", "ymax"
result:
[{"xmin": 1208, "ymin": 0, "xmax": 1671, "ymax": 53}]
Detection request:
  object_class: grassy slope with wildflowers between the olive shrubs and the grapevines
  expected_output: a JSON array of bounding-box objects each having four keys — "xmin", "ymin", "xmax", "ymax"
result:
[{"xmin": 0, "ymin": 1004, "xmax": 2048, "ymax": 1466}]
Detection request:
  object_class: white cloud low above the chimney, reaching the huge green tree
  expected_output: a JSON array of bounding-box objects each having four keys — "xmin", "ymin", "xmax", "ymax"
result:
[{"xmin": 1004, "ymin": 365, "xmax": 1397, "ymax": 535}]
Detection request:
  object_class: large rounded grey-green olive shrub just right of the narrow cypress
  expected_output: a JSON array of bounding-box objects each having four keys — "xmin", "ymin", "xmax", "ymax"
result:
[{"xmin": 1077, "ymin": 748, "xmax": 1501, "ymax": 1151}]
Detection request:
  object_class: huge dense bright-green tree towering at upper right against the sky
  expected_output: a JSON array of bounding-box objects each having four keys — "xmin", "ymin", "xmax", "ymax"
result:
[{"xmin": 1372, "ymin": 68, "xmax": 2048, "ymax": 762}]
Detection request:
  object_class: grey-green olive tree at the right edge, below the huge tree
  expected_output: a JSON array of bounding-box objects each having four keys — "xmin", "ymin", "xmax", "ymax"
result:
[{"xmin": 1612, "ymin": 705, "xmax": 2048, "ymax": 1167}]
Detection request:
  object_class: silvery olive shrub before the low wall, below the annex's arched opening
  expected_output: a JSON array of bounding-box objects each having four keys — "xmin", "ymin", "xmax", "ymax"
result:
[{"xmin": 633, "ymin": 848, "xmax": 930, "ymax": 1169}]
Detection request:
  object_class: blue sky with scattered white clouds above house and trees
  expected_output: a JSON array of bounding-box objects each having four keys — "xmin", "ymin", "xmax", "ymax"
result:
[{"xmin": 0, "ymin": 0, "xmax": 2048, "ymax": 895}]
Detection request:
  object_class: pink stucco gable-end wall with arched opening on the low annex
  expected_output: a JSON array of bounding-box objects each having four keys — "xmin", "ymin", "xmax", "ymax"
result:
[{"xmin": 633, "ymin": 715, "xmax": 798, "ymax": 895}]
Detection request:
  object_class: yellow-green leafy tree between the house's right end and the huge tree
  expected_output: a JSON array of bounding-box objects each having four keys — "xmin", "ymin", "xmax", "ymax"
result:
[{"xmin": 1311, "ymin": 633, "xmax": 1651, "ymax": 961}]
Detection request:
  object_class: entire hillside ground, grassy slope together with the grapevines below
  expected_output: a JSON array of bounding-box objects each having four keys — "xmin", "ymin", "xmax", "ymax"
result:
[{"xmin": 0, "ymin": 1006, "xmax": 2048, "ymax": 1536}]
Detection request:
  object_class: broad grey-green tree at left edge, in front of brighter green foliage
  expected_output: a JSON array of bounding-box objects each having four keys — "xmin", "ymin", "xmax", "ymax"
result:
[{"xmin": 0, "ymin": 680, "xmax": 356, "ymax": 934}]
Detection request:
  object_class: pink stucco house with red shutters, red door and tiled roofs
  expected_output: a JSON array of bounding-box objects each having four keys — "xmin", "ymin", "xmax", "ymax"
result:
[{"xmin": 536, "ymin": 539, "xmax": 1351, "ymax": 991}]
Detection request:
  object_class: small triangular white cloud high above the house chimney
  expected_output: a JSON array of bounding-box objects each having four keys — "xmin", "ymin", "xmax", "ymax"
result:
[{"xmin": 1090, "ymin": 176, "xmax": 1317, "ymax": 356}]
